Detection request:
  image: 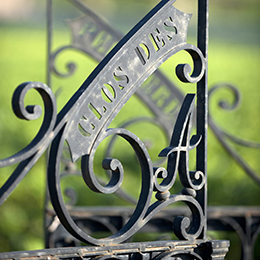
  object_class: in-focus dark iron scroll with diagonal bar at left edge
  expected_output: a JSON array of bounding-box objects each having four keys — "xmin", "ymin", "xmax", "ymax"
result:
[{"xmin": 0, "ymin": 82, "xmax": 57, "ymax": 204}]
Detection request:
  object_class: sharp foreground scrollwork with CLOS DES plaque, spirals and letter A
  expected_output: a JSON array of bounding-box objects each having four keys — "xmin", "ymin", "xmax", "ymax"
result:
[{"xmin": 0, "ymin": 0, "xmax": 210, "ymax": 253}]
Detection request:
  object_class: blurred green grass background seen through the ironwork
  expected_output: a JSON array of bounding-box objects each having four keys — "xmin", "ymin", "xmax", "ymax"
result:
[{"xmin": 0, "ymin": 0, "xmax": 260, "ymax": 252}]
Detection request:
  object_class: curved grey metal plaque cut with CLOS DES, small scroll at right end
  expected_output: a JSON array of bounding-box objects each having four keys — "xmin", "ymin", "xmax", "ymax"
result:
[{"xmin": 60, "ymin": 1, "xmax": 205, "ymax": 161}]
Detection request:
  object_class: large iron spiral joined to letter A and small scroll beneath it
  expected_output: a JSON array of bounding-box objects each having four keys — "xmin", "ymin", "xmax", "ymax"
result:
[{"xmin": 48, "ymin": 94, "xmax": 205, "ymax": 245}]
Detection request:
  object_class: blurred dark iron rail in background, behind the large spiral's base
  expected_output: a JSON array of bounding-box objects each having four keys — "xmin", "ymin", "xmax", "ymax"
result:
[{"xmin": 46, "ymin": 206, "xmax": 260, "ymax": 259}]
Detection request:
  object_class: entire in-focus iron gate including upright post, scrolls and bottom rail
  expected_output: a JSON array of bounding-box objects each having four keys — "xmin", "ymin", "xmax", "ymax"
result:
[{"xmin": 0, "ymin": 0, "xmax": 238, "ymax": 259}]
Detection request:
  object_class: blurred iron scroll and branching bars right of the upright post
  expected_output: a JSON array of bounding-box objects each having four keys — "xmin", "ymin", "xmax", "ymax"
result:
[{"xmin": 209, "ymin": 84, "xmax": 260, "ymax": 184}]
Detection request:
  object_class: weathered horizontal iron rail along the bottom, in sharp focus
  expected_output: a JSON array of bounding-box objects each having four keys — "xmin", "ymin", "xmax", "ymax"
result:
[{"xmin": 0, "ymin": 240, "xmax": 228, "ymax": 260}]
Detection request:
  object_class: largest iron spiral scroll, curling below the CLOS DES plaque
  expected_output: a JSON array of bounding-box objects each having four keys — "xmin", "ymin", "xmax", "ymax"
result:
[{"xmin": 48, "ymin": 125, "xmax": 153, "ymax": 245}]
